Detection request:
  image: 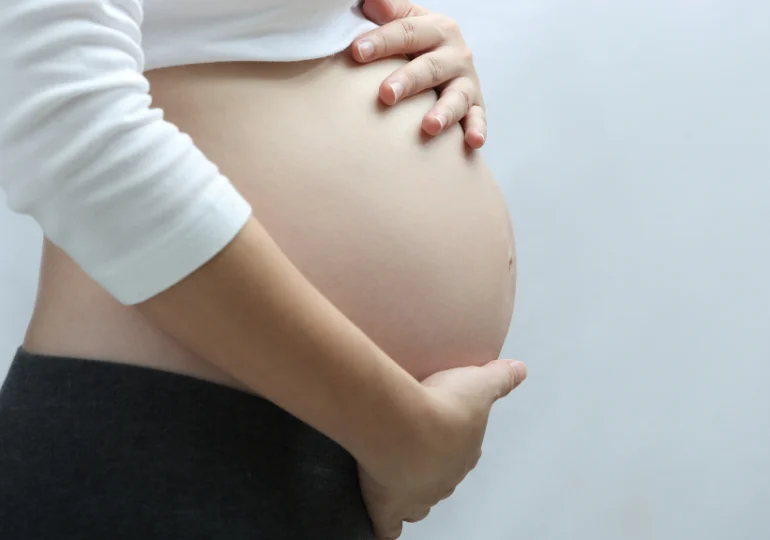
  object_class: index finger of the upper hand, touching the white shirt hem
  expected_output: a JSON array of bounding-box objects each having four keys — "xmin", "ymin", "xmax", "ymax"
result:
[{"xmin": 353, "ymin": 15, "xmax": 449, "ymax": 62}]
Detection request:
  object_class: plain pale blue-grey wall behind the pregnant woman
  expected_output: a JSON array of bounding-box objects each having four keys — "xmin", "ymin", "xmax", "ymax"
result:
[{"xmin": 0, "ymin": 0, "xmax": 770, "ymax": 540}]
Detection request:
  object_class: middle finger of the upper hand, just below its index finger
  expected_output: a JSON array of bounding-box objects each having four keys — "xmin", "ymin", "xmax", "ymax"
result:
[{"xmin": 379, "ymin": 48, "xmax": 464, "ymax": 105}]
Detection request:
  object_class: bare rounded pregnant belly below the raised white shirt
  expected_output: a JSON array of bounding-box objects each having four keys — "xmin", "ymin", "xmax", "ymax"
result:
[{"xmin": 24, "ymin": 55, "xmax": 515, "ymax": 378}]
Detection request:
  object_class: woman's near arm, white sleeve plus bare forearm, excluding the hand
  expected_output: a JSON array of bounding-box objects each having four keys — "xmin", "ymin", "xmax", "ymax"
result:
[{"xmin": 0, "ymin": 0, "xmax": 421, "ymax": 464}]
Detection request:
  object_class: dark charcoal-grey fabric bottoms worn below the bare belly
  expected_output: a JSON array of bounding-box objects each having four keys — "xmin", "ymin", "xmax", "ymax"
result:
[{"xmin": 0, "ymin": 350, "xmax": 374, "ymax": 540}]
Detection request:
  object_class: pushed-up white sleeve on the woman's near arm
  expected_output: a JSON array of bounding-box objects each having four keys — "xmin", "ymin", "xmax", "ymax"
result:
[{"xmin": 0, "ymin": 0, "xmax": 251, "ymax": 304}]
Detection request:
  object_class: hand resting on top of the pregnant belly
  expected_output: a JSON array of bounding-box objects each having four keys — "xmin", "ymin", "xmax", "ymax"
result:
[{"xmin": 351, "ymin": 0, "xmax": 487, "ymax": 148}]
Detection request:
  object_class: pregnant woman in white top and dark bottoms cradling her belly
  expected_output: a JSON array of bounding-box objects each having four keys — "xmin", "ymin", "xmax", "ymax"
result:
[{"xmin": 0, "ymin": 0, "xmax": 526, "ymax": 540}]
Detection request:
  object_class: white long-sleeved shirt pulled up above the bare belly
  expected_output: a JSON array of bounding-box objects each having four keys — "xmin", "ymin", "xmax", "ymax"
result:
[{"xmin": 0, "ymin": 0, "xmax": 371, "ymax": 304}]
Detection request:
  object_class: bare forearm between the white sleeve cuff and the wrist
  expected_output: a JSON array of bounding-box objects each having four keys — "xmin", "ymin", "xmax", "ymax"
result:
[{"xmin": 137, "ymin": 218, "xmax": 424, "ymax": 459}]
